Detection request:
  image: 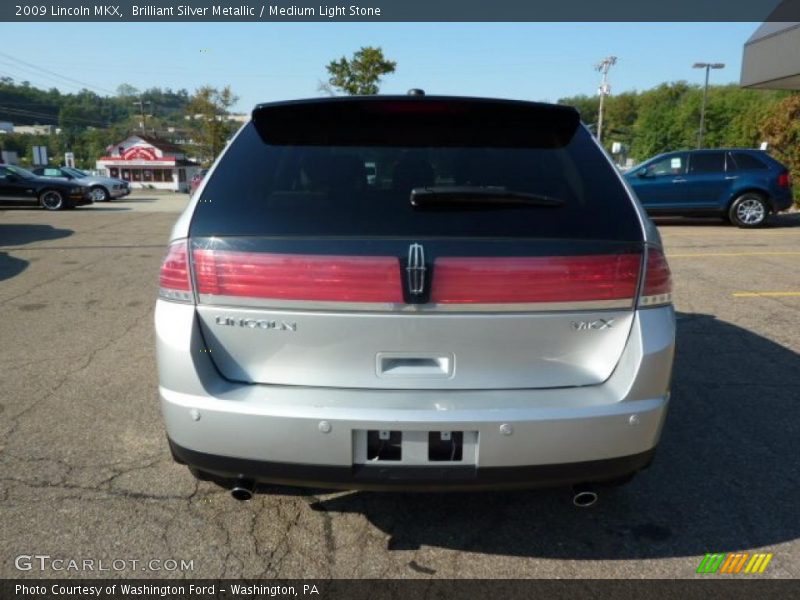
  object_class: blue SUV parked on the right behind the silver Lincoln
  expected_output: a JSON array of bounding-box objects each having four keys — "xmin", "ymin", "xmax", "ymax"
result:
[{"xmin": 625, "ymin": 148, "xmax": 793, "ymax": 227}]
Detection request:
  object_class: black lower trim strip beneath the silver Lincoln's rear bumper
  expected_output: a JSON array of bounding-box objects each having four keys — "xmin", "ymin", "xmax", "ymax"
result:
[{"xmin": 169, "ymin": 440, "xmax": 655, "ymax": 491}]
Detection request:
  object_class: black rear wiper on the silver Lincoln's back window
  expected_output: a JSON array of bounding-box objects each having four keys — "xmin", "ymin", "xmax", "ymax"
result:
[{"xmin": 411, "ymin": 185, "xmax": 564, "ymax": 208}]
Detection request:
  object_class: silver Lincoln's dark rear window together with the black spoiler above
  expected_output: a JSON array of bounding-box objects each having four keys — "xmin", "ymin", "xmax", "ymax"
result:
[{"xmin": 190, "ymin": 100, "xmax": 642, "ymax": 241}]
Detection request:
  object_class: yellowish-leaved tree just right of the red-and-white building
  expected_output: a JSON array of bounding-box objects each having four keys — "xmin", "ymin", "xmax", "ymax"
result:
[{"xmin": 186, "ymin": 85, "xmax": 239, "ymax": 162}]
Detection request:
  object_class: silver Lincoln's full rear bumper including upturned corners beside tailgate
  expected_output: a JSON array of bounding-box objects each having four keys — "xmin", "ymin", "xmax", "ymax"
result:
[{"xmin": 155, "ymin": 300, "xmax": 675, "ymax": 489}]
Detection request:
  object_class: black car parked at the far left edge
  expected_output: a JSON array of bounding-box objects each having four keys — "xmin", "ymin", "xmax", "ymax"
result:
[{"xmin": 0, "ymin": 165, "xmax": 92, "ymax": 210}]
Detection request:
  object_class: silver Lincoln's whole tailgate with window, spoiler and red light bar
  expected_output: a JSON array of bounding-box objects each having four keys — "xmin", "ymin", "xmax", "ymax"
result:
[{"xmin": 190, "ymin": 98, "xmax": 643, "ymax": 389}]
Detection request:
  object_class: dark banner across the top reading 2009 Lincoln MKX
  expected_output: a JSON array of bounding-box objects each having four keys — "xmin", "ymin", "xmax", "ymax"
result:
[{"xmin": 0, "ymin": 0, "xmax": 800, "ymax": 22}]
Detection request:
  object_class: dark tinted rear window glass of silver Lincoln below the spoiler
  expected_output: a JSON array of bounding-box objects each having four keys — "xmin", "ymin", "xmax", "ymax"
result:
[{"xmin": 190, "ymin": 102, "xmax": 643, "ymax": 241}]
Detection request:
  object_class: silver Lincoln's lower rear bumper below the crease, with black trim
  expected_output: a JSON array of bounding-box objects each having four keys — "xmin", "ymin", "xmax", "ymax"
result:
[{"xmin": 161, "ymin": 390, "xmax": 668, "ymax": 489}]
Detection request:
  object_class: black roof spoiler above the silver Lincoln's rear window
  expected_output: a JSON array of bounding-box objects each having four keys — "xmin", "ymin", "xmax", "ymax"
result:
[{"xmin": 252, "ymin": 96, "xmax": 580, "ymax": 148}]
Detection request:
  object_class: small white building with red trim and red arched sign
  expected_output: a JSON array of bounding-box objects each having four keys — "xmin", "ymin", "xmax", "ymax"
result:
[{"xmin": 97, "ymin": 135, "xmax": 200, "ymax": 192}]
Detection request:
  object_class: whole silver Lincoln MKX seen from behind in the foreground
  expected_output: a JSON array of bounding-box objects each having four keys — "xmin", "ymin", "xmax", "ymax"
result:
[{"xmin": 155, "ymin": 95, "xmax": 675, "ymax": 505}]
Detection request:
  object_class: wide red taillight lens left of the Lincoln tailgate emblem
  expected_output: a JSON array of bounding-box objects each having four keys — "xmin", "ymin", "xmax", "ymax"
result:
[{"xmin": 194, "ymin": 249, "xmax": 403, "ymax": 302}]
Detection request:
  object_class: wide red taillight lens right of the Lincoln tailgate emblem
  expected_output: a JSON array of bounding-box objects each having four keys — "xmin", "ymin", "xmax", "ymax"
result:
[{"xmin": 431, "ymin": 254, "xmax": 641, "ymax": 304}]
